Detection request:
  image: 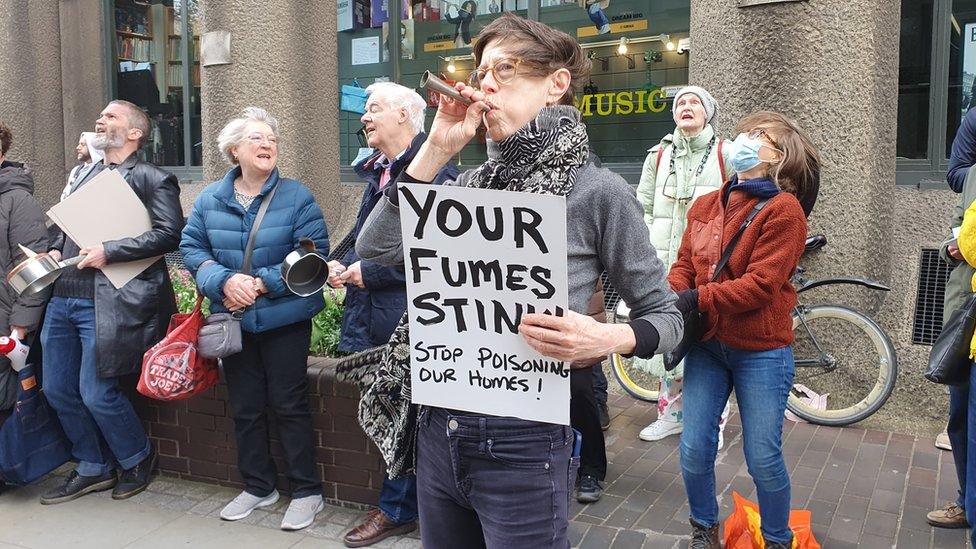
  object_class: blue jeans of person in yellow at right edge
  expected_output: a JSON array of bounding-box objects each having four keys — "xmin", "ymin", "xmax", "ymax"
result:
[{"xmin": 946, "ymin": 368, "xmax": 976, "ymax": 544}]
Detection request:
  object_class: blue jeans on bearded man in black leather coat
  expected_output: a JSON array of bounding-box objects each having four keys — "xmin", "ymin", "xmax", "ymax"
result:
[{"xmin": 41, "ymin": 297, "xmax": 149, "ymax": 477}]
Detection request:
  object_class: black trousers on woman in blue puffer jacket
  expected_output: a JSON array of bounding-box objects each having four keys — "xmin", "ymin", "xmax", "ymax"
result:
[{"xmin": 223, "ymin": 320, "xmax": 322, "ymax": 498}]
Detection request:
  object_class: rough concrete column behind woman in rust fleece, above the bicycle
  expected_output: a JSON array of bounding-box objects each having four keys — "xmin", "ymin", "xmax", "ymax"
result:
[{"xmin": 689, "ymin": 0, "xmax": 900, "ymax": 280}]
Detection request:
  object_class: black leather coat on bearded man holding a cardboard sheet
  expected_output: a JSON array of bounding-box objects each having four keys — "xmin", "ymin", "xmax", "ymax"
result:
[{"xmin": 52, "ymin": 154, "xmax": 184, "ymax": 377}]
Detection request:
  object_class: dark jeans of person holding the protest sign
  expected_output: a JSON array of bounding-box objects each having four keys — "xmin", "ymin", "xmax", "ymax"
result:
[{"xmin": 417, "ymin": 404, "xmax": 576, "ymax": 549}]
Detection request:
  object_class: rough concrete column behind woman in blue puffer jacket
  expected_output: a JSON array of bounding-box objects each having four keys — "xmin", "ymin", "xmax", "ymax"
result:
[{"xmin": 201, "ymin": 0, "xmax": 342, "ymax": 229}]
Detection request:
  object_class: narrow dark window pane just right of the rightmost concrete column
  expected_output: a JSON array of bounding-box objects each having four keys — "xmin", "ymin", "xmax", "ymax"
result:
[{"xmin": 896, "ymin": 0, "xmax": 933, "ymax": 158}]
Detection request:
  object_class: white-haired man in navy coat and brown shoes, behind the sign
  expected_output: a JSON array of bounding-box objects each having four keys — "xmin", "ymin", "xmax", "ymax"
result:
[{"xmin": 329, "ymin": 82, "xmax": 458, "ymax": 547}]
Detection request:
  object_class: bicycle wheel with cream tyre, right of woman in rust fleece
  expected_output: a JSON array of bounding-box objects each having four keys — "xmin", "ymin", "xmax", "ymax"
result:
[{"xmin": 786, "ymin": 305, "xmax": 898, "ymax": 426}]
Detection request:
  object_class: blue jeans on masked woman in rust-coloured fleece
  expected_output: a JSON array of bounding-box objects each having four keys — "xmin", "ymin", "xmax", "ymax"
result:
[{"xmin": 681, "ymin": 339, "xmax": 793, "ymax": 542}]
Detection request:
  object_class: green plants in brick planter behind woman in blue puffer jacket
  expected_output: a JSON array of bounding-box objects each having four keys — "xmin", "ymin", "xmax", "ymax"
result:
[{"xmin": 169, "ymin": 267, "xmax": 346, "ymax": 356}]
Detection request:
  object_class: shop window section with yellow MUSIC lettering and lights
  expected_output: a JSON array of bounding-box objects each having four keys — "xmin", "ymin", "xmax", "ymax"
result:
[{"xmin": 539, "ymin": 0, "xmax": 691, "ymax": 163}]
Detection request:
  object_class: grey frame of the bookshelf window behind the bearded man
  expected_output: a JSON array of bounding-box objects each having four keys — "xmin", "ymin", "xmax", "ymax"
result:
[{"xmin": 102, "ymin": 0, "xmax": 204, "ymax": 181}]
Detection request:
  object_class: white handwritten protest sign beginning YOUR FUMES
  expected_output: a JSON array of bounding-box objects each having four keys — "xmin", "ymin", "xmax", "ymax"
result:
[{"xmin": 400, "ymin": 184, "xmax": 569, "ymax": 425}]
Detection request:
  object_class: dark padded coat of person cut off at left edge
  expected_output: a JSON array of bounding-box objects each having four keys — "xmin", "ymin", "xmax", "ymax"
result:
[{"xmin": 0, "ymin": 162, "xmax": 48, "ymax": 410}]
